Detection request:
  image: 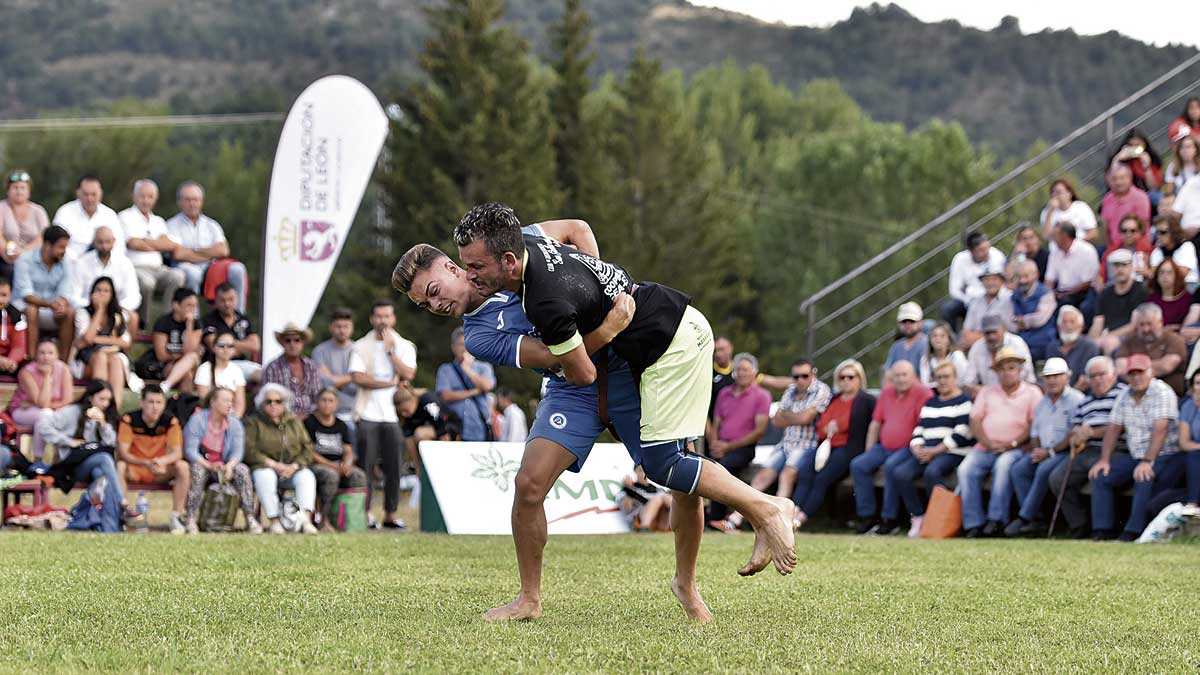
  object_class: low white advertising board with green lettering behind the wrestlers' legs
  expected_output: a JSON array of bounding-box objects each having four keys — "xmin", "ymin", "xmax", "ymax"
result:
[{"xmin": 420, "ymin": 441, "xmax": 634, "ymax": 534}]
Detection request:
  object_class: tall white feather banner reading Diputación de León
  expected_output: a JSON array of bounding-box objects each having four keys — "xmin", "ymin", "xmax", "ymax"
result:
[{"xmin": 262, "ymin": 74, "xmax": 388, "ymax": 363}]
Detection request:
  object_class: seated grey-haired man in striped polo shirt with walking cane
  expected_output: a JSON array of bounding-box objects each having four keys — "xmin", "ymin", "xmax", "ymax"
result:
[{"xmin": 1050, "ymin": 357, "xmax": 1126, "ymax": 539}]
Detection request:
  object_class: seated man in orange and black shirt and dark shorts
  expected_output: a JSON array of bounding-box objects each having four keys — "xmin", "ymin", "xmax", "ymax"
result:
[{"xmin": 116, "ymin": 384, "xmax": 192, "ymax": 534}]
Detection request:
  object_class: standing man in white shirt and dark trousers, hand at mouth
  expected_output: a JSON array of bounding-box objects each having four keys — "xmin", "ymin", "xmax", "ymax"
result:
[{"xmin": 350, "ymin": 300, "xmax": 416, "ymax": 530}]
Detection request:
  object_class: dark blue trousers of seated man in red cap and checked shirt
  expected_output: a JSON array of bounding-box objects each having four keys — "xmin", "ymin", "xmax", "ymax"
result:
[{"xmin": 1092, "ymin": 453, "xmax": 1188, "ymax": 534}]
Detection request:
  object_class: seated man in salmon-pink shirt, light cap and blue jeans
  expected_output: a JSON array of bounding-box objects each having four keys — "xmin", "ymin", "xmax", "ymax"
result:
[{"xmin": 959, "ymin": 348, "xmax": 1042, "ymax": 538}]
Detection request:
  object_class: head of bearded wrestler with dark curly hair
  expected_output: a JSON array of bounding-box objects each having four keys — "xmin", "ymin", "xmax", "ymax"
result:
[{"xmin": 454, "ymin": 202, "xmax": 524, "ymax": 295}]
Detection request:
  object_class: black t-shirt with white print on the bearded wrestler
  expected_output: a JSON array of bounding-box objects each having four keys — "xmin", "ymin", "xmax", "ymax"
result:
[{"xmin": 521, "ymin": 229, "xmax": 691, "ymax": 372}]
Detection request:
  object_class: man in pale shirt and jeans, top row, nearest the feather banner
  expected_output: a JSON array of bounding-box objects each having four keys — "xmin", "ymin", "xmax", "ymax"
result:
[{"xmin": 167, "ymin": 180, "xmax": 247, "ymax": 311}]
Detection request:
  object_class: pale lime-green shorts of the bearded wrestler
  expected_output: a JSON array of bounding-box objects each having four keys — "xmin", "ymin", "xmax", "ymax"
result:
[{"xmin": 640, "ymin": 305, "xmax": 713, "ymax": 444}]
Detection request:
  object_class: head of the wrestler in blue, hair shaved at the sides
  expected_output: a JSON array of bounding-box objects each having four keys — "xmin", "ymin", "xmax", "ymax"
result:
[{"xmin": 391, "ymin": 244, "xmax": 472, "ymax": 317}]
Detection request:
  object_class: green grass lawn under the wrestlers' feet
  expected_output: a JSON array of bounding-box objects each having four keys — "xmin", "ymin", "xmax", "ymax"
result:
[{"xmin": 0, "ymin": 532, "xmax": 1200, "ymax": 673}]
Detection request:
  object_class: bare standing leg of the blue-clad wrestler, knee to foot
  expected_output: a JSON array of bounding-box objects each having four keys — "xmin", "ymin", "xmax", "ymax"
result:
[{"xmin": 484, "ymin": 438, "xmax": 575, "ymax": 621}]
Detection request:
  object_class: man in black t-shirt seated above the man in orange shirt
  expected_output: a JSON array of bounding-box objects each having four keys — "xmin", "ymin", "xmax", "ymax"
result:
[{"xmin": 137, "ymin": 288, "xmax": 200, "ymax": 393}]
